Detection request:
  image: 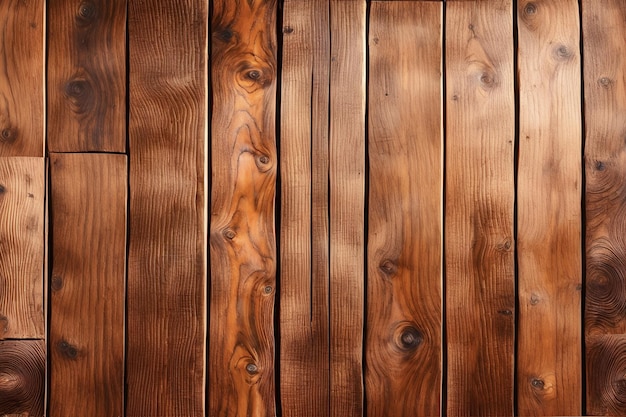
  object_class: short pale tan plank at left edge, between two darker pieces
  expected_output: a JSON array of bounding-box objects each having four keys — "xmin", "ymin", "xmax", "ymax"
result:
[{"xmin": 0, "ymin": 157, "xmax": 45, "ymax": 339}]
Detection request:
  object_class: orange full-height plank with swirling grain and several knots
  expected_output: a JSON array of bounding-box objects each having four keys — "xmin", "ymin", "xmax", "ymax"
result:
[{"xmin": 209, "ymin": 0, "xmax": 278, "ymax": 416}]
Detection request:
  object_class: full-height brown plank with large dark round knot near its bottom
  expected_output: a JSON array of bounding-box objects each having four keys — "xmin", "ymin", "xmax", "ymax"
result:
[{"xmin": 365, "ymin": 2, "xmax": 443, "ymax": 417}]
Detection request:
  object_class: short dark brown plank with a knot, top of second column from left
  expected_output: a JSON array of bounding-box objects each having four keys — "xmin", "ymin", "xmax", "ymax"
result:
[{"xmin": 47, "ymin": 0, "xmax": 126, "ymax": 152}]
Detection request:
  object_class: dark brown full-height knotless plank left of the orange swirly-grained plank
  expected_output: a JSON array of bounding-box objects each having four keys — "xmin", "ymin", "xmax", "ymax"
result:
[{"xmin": 126, "ymin": 0, "xmax": 208, "ymax": 416}]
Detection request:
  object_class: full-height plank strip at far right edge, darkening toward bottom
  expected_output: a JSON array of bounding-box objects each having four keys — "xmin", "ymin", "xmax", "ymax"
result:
[{"xmin": 581, "ymin": 0, "xmax": 626, "ymax": 415}]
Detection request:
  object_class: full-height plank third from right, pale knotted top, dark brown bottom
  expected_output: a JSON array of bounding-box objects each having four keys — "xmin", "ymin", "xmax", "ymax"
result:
[{"xmin": 444, "ymin": 0, "xmax": 515, "ymax": 416}]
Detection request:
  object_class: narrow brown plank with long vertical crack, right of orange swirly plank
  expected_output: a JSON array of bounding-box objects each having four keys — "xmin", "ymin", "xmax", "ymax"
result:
[{"xmin": 280, "ymin": 0, "xmax": 330, "ymax": 417}]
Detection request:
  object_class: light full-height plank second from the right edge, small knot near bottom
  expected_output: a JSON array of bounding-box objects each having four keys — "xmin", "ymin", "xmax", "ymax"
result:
[{"xmin": 517, "ymin": 0, "xmax": 582, "ymax": 416}]
